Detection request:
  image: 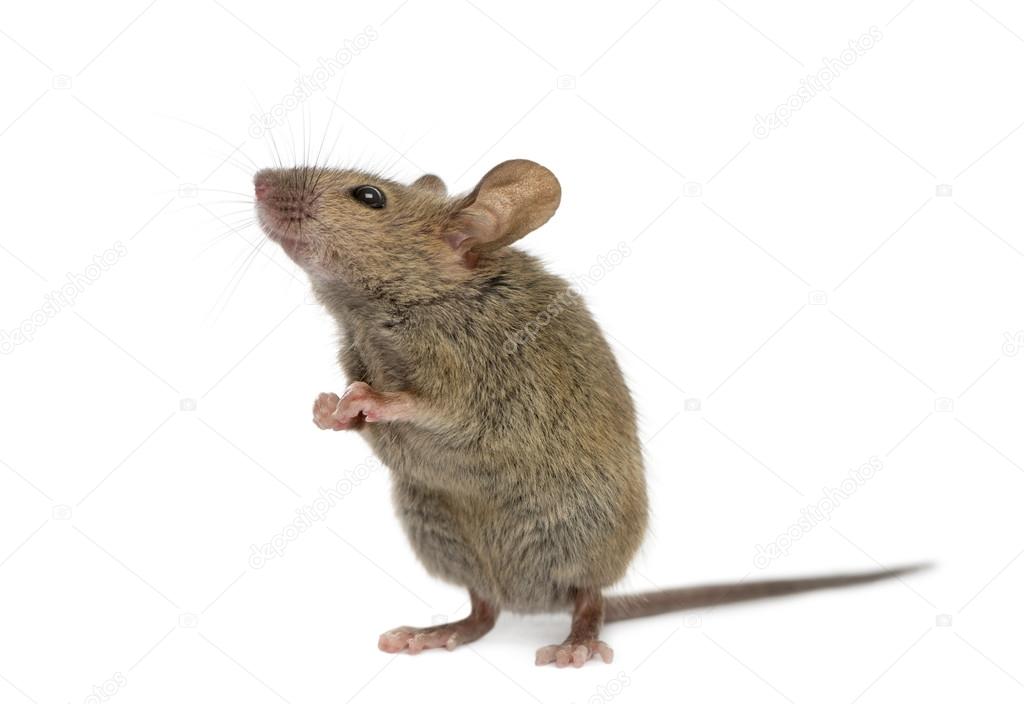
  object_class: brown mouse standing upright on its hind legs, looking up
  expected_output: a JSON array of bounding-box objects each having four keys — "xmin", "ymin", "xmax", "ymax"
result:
[{"xmin": 254, "ymin": 159, "xmax": 922, "ymax": 667}]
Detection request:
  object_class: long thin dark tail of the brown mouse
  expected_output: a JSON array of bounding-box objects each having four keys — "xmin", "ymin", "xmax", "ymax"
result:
[{"xmin": 604, "ymin": 564, "xmax": 931, "ymax": 622}]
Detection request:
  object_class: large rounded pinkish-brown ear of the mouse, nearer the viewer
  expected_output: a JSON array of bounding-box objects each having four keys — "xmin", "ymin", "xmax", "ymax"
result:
[{"xmin": 444, "ymin": 159, "xmax": 562, "ymax": 266}]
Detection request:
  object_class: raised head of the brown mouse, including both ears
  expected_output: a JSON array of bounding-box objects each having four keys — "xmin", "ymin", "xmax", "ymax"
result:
[{"xmin": 254, "ymin": 160, "xmax": 561, "ymax": 303}]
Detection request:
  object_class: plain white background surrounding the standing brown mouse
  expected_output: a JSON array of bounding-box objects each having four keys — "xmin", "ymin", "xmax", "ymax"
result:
[{"xmin": 0, "ymin": 0, "xmax": 1024, "ymax": 704}]
